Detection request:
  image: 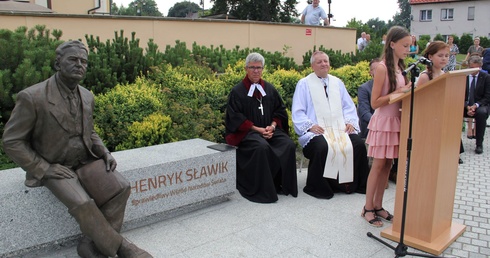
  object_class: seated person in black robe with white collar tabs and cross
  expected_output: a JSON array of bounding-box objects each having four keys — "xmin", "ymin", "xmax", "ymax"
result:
[{"xmin": 225, "ymin": 53, "xmax": 298, "ymax": 203}]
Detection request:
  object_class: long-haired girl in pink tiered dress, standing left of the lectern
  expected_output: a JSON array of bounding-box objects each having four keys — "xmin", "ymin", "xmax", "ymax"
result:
[{"xmin": 361, "ymin": 26, "xmax": 412, "ymax": 227}]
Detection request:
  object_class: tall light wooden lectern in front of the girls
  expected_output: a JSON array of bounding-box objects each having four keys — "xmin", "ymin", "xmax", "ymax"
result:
[{"xmin": 381, "ymin": 69, "xmax": 477, "ymax": 255}]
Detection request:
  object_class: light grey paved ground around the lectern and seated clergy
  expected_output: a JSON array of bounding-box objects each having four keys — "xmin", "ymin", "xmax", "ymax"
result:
[{"xmin": 29, "ymin": 130, "xmax": 490, "ymax": 258}]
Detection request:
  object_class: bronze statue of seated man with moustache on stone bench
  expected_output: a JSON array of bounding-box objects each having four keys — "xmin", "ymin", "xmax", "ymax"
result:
[{"xmin": 3, "ymin": 41, "xmax": 151, "ymax": 257}]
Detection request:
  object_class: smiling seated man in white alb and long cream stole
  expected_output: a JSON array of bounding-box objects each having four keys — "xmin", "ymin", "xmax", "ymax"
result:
[{"xmin": 292, "ymin": 51, "xmax": 369, "ymax": 199}]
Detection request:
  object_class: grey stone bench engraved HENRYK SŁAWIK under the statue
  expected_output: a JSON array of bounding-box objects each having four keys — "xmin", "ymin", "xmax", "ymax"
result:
[{"xmin": 0, "ymin": 139, "xmax": 236, "ymax": 257}]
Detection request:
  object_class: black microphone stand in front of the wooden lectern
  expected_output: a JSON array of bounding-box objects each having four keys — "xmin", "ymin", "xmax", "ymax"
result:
[{"xmin": 367, "ymin": 59, "xmax": 439, "ymax": 257}]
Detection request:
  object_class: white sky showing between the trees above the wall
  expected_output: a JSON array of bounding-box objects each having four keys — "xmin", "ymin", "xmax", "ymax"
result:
[{"xmin": 113, "ymin": 0, "xmax": 399, "ymax": 27}]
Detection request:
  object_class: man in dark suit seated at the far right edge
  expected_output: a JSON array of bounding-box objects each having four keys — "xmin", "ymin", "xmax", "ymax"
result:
[{"xmin": 464, "ymin": 56, "xmax": 490, "ymax": 154}]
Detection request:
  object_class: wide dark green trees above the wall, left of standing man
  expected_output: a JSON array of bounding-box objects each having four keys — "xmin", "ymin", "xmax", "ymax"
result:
[{"xmin": 211, "ymin": 0, "xmax": 298, "ymax": 22}]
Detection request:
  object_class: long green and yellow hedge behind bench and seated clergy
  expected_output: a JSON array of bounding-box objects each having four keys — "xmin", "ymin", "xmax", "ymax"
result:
[{"xmin": 0, "ymin": 26, "xmax": 402, "ymax": 167}]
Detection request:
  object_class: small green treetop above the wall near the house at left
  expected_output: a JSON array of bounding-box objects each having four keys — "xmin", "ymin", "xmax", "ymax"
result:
[{"xmin": 111, "ymin": 0, "xmax": 163, "ymax": 16}]
